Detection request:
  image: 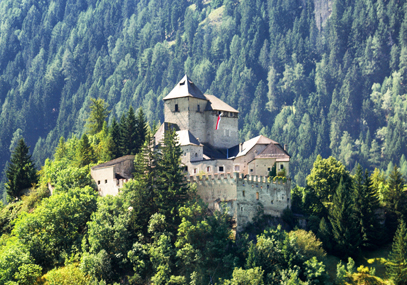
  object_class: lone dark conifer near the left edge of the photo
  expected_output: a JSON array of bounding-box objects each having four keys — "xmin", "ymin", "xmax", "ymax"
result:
[{"xmin": 5, "ymin": 138, "xmax": 38, "ymax": 201}]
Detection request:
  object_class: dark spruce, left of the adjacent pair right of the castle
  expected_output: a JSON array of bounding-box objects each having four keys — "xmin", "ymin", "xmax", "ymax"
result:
[{"xmin": 329, "ymin": 176, "xmax": 360, "ymax": 259}]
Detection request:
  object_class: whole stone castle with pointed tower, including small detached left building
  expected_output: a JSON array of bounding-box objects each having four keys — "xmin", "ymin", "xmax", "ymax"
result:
[{"xmin": 91, "ymin": 75, "xmax": 291, "ymax": 228}]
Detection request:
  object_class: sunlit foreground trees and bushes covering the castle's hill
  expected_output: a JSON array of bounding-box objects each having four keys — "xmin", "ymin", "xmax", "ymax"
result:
[{"xmin": 0, "ymin": 101, "xmax": 407, "ymax": 285}]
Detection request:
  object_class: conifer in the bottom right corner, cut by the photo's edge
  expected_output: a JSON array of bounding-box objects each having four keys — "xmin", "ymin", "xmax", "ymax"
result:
[{"xmin": 386, "ymin": 220, "xmax": 407, "ymax": 284}]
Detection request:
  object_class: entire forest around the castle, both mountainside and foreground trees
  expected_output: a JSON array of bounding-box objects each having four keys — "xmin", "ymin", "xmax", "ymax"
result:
[{"xmin": 0, "ymin": 0, "xmax": 407, "ymax": 285}]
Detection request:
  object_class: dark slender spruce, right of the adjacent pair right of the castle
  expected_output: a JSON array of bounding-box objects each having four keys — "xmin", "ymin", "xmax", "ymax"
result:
[{"xmin": 353, "ymin": 164, "xmax": 382, "ymax": 249}]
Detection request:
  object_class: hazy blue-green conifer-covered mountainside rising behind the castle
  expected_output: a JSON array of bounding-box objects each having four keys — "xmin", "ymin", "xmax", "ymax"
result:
[{"xmin": 0, "ymin": 0, "xmax": 407, "ymax": 190}]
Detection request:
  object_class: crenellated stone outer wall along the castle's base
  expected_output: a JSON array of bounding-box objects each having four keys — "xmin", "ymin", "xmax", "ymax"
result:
[{"xmin": 189, "ymin": 173, "xmax": 291, "ymax": 230}]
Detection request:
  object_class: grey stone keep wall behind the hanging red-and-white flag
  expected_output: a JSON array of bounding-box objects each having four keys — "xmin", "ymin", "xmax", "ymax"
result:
[{"xmin": 205, "ymin": 111, "xmax": 239, "ymax": 148}]
